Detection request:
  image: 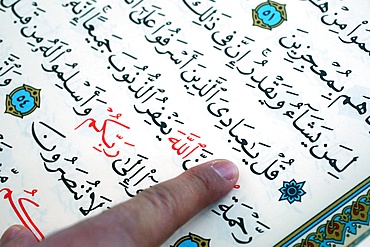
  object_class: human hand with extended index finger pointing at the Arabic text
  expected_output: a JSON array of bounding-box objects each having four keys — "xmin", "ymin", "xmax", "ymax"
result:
[{"xmin": 0, "ymin": 160, "xmax": 239, "ymax": 247}]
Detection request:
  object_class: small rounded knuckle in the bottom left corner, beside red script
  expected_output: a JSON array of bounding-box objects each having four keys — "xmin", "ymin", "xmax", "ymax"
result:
[{"xmin": 0, "ymin": 225, "xmax": 37, "ymax": 247}]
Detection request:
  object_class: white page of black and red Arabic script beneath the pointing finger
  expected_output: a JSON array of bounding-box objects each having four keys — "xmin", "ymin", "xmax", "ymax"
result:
[{"xmin": 0, "ymin": 0, "xmax": 370, "ymax": 246}]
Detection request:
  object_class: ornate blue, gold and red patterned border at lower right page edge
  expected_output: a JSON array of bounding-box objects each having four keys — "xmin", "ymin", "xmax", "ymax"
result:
[{"xmin": 275, "ymin": 176, "xmax": 370, "ymax": 247}]
